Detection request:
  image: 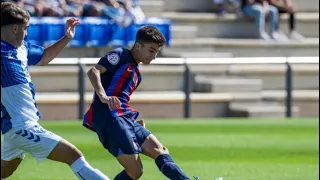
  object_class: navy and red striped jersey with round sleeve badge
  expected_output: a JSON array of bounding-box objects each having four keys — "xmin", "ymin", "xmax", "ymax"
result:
[{"xmin": 83, "ymin": 48, "xmax": 141, "ymax": 130}]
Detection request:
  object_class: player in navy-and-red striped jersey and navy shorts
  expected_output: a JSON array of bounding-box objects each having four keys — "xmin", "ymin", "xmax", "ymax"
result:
[{"xmin": 83, "ymin": 26, "xmax": 189, "ymax": 180}]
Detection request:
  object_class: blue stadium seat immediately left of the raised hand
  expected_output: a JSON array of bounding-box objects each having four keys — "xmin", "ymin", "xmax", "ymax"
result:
[{"xmin": 41, "ymin": 17, "xmax": 65, "ymax": 46}]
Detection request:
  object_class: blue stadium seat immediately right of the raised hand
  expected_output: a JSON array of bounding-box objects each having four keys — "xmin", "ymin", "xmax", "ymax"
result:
[{"xmin": 83, "ymin": 17, "xmax": 112, "ymax": 47}]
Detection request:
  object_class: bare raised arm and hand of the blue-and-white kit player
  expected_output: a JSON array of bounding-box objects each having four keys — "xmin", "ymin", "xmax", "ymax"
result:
[{"xmin": 37, "ymin": 18, "xmax": 80, "ymax": 66}]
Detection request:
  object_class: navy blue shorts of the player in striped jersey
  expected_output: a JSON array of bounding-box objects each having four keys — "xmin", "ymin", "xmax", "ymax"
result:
[{"xmin": 89, "ymin": 103, "xmax": 151, "ymax": 157}]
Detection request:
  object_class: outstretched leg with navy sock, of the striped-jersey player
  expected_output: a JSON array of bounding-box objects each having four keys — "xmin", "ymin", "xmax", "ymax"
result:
[{"xmin": 142, "ymin": 134, "xmax": 190, "ymax": 180}]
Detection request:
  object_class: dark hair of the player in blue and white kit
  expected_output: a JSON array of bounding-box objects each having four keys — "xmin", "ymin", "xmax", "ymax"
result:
[{"xmin": 1, "ymin": 2, "xmax": 30, "ymax": 27}]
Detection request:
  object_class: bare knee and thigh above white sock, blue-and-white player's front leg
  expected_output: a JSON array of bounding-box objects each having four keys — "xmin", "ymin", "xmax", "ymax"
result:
[{"xmin": 47, "ymin": 139, "xmax": 83, "ymax": 165}]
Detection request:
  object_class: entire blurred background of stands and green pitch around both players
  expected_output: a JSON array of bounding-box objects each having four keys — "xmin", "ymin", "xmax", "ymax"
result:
[{"xmin": 1, "ymin": 0, "xmax": 319, "ymax": 180}]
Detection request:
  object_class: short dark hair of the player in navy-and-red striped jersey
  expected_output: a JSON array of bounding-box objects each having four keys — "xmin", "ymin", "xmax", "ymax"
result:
[{"xmin": 136, "ymin": 26, "xmax": 166, "ymax": 46}]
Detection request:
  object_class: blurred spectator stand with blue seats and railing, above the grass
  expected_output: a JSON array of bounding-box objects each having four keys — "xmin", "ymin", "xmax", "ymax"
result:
[{"xmin": 2, "ymin": 0, "xmax": 319, "ymax": 120}]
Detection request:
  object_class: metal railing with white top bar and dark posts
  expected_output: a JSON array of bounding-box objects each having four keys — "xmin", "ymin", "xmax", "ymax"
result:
[{"xmin": 50, "ymin": 57, "xmax": 319, "ymax": 119}]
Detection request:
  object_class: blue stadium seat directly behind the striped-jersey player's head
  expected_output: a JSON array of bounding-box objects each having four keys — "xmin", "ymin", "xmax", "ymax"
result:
[{"xmin": 127, "ymin": 18, "xmax": 171, "ymax": 46}]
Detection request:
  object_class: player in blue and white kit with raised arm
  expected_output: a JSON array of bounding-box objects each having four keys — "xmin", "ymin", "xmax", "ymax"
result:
[{"xmin": 1, "ymin": 2, "xmax": 109, "ymax": 180}]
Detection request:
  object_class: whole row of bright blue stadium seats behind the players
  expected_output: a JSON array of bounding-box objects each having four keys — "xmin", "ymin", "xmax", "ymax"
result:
[{"xmin": 26, "ymin": 17, "xmax": 171, "ymax": 47}]
